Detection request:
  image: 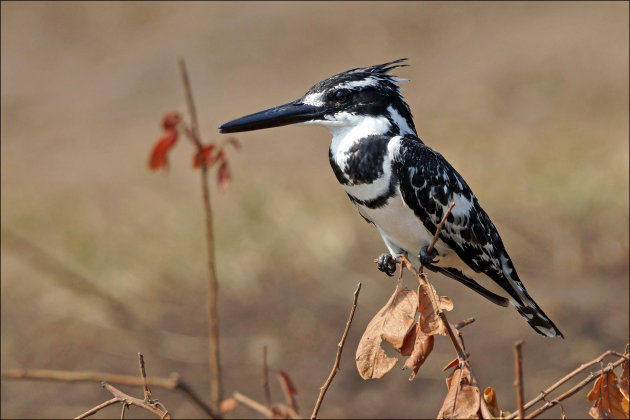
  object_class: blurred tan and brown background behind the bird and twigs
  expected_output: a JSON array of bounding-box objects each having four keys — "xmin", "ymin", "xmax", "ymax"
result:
[{"xmin": 1, "ymin": 2, "xmax": 629, "ymax": 418}]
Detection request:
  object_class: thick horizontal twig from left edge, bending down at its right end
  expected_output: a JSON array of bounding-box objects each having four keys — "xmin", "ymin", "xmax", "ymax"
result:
[{"xmin": 2, "ymin": 369, "xmax": 219, "ymax": 418}]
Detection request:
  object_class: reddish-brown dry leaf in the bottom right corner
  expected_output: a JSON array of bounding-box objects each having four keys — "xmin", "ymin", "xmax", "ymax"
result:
[{"xmin": 586, "ymin": 370, "xmax": 628, "ymax": 419}]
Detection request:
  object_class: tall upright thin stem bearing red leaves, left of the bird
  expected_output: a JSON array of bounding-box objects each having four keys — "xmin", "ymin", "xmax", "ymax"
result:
[{"xmin": 179, "ymin": 59, "xmax": 221, "ymax": 413}]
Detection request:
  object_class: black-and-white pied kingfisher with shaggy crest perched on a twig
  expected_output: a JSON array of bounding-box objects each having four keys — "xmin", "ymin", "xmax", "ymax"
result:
[{"xmin": 219, "ymin": 58, "xmax": 564, "ymax": 338}]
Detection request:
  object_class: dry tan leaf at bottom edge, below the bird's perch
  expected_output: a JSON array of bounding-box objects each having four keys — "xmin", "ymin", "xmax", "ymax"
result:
[{"xmin": 437, "ymin": 365, "xmax": 481, "ymax": 419}]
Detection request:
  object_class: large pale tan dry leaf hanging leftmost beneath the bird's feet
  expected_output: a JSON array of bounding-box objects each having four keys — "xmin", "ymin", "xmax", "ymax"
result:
[{"xmin": 356, "ymin": 288, "xmax": 418, "ymax": 379}]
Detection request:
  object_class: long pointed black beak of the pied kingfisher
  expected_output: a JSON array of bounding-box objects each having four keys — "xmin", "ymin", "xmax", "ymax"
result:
[{"xmin": 219, "ymin": 99, "xmax": 323, "ymax": 133}]
